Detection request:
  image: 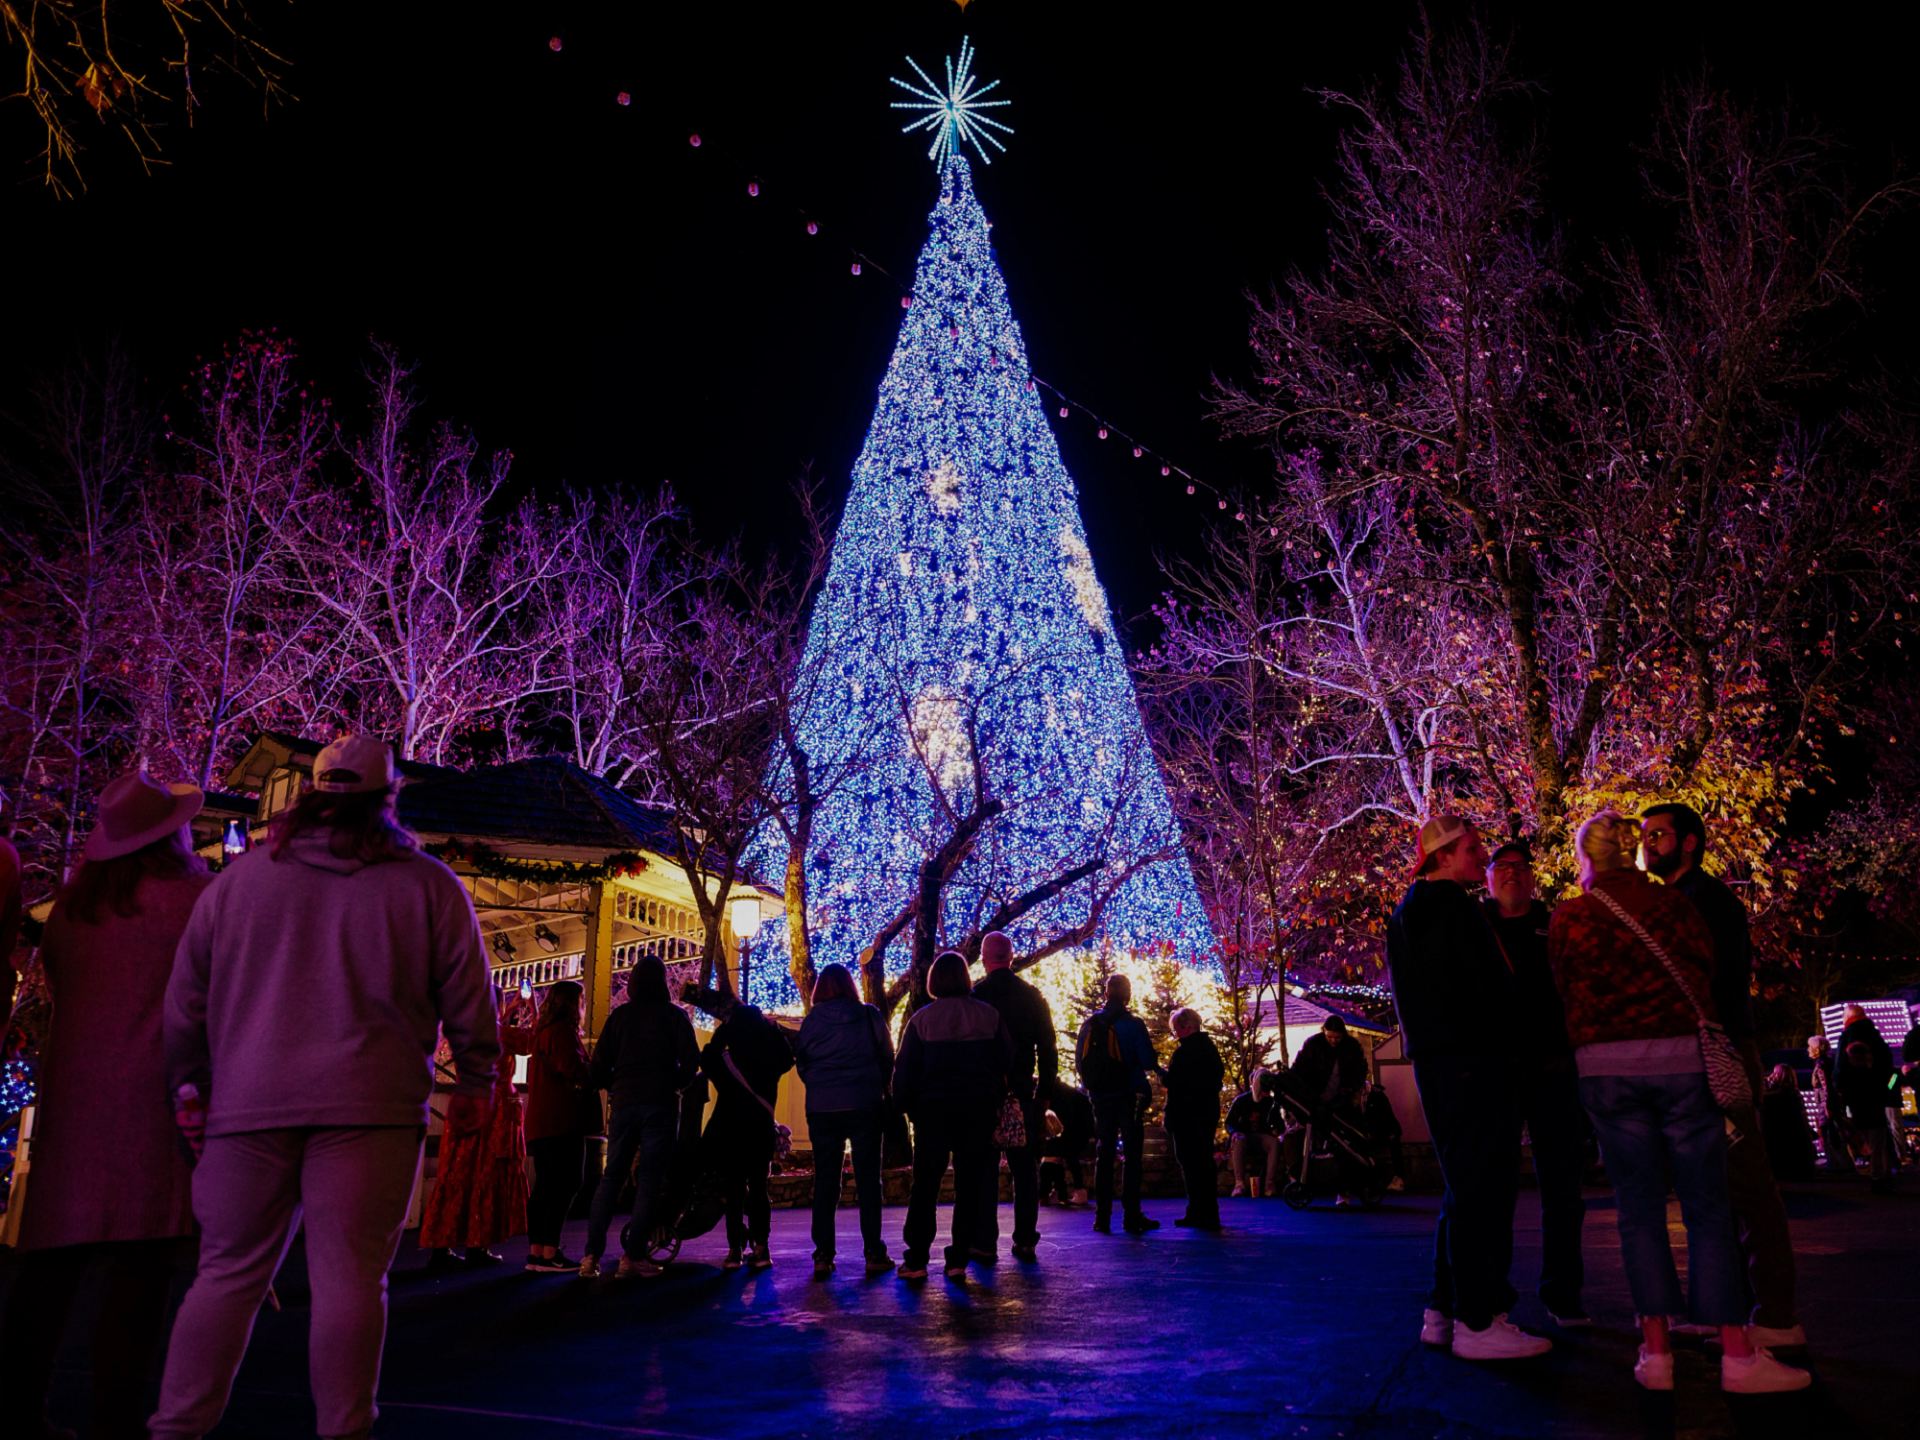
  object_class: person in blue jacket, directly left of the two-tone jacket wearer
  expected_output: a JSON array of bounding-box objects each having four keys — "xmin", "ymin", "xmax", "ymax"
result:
[{"xmin": 793, "ymin": 966, "xmax": 893, "ymax": 1281}]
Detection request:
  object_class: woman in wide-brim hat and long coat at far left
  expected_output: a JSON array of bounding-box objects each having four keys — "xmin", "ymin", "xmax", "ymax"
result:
[{"xmin": 0, "ymin": 774, "xmax": 213, "ymax": 1436}]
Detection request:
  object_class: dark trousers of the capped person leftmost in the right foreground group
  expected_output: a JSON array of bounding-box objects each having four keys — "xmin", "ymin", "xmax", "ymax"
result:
[{"xmin": 1413, "ymin": 1056, "xmax": 1521, "ymax": 1331}]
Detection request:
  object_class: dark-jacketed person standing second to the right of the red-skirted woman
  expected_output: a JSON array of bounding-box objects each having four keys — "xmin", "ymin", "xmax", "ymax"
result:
[{"xmin": 580, "ymin": 954, "xmax": 701, "ymax": 1279}]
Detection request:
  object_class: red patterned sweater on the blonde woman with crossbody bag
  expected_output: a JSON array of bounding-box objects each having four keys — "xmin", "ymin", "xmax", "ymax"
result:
[{"xmin": 1548, "ymin": 868, "xmax": 1713, "ymax": 1048}]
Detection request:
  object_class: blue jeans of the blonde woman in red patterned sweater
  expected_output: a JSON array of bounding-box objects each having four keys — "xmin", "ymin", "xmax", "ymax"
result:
[{"xmin": 1580, "ymin": 1073, "xmax": 1751, "ymax": 1325}]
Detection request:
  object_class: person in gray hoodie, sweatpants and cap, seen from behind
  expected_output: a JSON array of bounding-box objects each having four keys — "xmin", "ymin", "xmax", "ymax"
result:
[{"xmin": 150, "ymin": 735, "xmax": 499, "ymax": 1436}]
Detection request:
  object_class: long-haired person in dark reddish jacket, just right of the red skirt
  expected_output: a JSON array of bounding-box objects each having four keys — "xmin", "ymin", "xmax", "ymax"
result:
[{"xmin": 526, "ymin": 979, "xmax": 607, "ymax": 1275}]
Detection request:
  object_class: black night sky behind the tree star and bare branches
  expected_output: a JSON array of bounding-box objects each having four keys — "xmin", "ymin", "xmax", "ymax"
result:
[{"xmin": 11, "ymin": 0, "xmax": 1920, "ymax": 616}]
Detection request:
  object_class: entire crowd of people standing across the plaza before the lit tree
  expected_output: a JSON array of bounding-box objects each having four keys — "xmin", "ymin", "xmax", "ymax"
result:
[{"xmin": 0, "ymin": 737, "xmax": 1916, "ymax": 1436}]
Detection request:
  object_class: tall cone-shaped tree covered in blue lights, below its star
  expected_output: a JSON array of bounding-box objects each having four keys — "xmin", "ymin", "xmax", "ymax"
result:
[{"xmin": 749, "ymin": 152, "xmax": 1215, "ymax": 1008}]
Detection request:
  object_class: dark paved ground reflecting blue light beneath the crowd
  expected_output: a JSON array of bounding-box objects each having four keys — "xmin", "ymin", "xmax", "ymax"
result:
[{"xmin": 8, "ymin": 1177, "xmax": 1920, "ymax": 1440}]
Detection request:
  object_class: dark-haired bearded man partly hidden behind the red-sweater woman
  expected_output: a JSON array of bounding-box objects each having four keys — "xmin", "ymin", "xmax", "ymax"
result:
[{"xmin": 1640, "ymin": 804, "xmax": 1807, "ymax": 1346}]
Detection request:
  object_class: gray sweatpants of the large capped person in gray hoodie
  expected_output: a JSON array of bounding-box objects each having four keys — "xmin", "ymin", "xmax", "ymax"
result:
[{"xmin": 150, "ymin": 1125, "xmax": 424, "ymax": 1436}]
